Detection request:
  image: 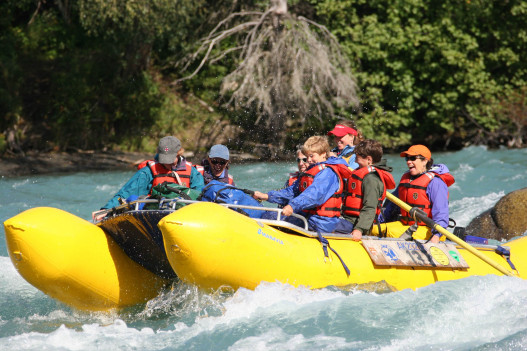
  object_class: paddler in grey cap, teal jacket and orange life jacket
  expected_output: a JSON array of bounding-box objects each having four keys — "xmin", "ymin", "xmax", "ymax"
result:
[{"xmin": 101, "ymin": 136, "xmax": 205, "ymax": 209}]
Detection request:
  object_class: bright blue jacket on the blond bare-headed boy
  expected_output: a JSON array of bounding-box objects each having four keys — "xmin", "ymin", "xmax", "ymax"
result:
[{"xmin": 267, "ymin": 157, "xmax": 347, "ymax": 233}]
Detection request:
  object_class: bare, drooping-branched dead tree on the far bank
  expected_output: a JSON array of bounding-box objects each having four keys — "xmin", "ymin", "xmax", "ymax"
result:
[{"xmin": 174, "ymin": 0, "xmax": 358, "ymax": 154}]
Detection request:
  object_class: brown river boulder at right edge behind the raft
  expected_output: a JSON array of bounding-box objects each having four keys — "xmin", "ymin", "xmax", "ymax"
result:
[{"xmin": 466, "ymin": 188, "xmax": 527, "ymax": 240}]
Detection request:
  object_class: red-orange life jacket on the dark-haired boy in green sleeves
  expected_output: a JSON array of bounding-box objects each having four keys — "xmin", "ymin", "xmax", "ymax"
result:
[{"xmin": 342, "ymin": 166, "xmax": 395, "ymax": 220}]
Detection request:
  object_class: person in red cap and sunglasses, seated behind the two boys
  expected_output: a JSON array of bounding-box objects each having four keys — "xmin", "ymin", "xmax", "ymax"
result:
[{"xmin": 328, "ymin": 119, "xmax": 362, "ymax": 169}]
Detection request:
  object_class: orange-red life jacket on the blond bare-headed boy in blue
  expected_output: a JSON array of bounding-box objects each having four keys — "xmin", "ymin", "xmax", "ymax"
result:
[{"xmin": 299, "ymin": 163, "xmax": 348, "ymax": 217}]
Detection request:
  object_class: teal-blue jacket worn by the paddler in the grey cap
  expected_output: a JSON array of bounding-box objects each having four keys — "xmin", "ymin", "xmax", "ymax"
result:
[{"xmin": 101, "ymin": 155, "xmax": 205, "ymax": 209}]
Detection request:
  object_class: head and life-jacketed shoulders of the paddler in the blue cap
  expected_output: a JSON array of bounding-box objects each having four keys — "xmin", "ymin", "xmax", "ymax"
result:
[{"xmin": 194, "ymin": 144, "xmax": 235, "ymax": 186}]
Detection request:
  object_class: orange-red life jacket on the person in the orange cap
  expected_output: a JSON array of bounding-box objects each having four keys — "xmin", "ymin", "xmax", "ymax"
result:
[{"xmin": 398, "ymin": 172, "xmax": 455, "ymax": 225}]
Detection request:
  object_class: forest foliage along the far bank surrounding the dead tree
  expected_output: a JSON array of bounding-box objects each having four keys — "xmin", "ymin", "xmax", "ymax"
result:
[{"xmin": 0, "ymin": 0, "xmax": 527, "ymax": 154}]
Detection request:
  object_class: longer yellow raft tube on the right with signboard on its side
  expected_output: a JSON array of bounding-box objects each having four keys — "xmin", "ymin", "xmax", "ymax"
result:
[{"xmin": 158, "ymin": 203, "xmax": 527, "ymax": 290}]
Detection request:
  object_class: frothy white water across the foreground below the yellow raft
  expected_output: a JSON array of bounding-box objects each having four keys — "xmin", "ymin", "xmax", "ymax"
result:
[{"xmin": 0, "ymin": 268, "xmax": 527, "ymax": 351}]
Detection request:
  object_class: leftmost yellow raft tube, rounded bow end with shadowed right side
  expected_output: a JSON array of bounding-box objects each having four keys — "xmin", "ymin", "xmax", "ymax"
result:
[{"xmin": 4, "ymin": 207, "xmax": 168, "ymax": 311}]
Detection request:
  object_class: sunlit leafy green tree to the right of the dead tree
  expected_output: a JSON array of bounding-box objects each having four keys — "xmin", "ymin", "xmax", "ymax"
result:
[{"xmin": 311, "ymin": 0, "xmax": 527, "ymax": 146}]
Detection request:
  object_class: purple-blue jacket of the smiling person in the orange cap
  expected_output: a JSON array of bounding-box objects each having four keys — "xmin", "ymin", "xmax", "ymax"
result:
[{"xmin": 381, "ymin": 164, "xmax": 449, "ymax": 235}]
